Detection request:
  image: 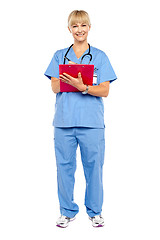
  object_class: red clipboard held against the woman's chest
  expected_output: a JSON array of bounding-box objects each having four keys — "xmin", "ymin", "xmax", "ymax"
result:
[{"xmin": 59, "ymin": 64, "xmax": 94, "ymax": 92}]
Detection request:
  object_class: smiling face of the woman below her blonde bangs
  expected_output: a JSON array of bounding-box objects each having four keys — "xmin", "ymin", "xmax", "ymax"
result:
[{"xmin": 68, "ymin": 23, "xmax": 91, "ymax": 42}]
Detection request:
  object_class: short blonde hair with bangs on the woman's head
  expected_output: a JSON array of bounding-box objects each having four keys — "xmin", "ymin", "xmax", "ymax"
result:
[{"xmin": 68, "ymin": 10, "xmax": 91, "ymax": 27}]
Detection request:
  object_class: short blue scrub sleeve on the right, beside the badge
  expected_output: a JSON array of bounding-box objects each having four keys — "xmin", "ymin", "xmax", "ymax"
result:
[{"xmin": 99, "ymin": 52, "xmax": 117, "ymax": 84}]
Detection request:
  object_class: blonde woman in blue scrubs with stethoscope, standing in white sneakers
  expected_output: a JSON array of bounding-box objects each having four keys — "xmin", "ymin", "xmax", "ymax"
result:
[{"xmin": 45, "ymin": 10, "xmax": 117, "ymax": 227}]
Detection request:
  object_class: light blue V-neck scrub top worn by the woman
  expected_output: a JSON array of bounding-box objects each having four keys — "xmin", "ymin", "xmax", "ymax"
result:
[{"xmin": 44, "ymin": 46, "xmax": 117, "ymax": 128}]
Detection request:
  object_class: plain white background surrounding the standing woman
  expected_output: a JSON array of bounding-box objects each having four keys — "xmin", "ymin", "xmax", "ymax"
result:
[{"xmin": 0, "ymin": 0, "xmax": 160, "ymax": 240}]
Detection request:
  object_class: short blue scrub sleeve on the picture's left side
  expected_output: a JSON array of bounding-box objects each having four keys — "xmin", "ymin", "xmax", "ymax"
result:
[{"xmin": 44, "ymin": 52, "xmax": 59, "ymax": 80}]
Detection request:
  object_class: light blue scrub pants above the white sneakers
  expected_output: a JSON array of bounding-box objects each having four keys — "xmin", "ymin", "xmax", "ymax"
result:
[{"xmin": 54, "ymin": 127, "xmax": 105, "ymax": 218}]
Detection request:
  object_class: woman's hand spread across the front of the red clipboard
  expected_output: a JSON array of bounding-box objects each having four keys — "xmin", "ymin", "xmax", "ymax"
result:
[{"xmin": 59, "ymin": 72, "xmax": 85, "ymax": 91}]
